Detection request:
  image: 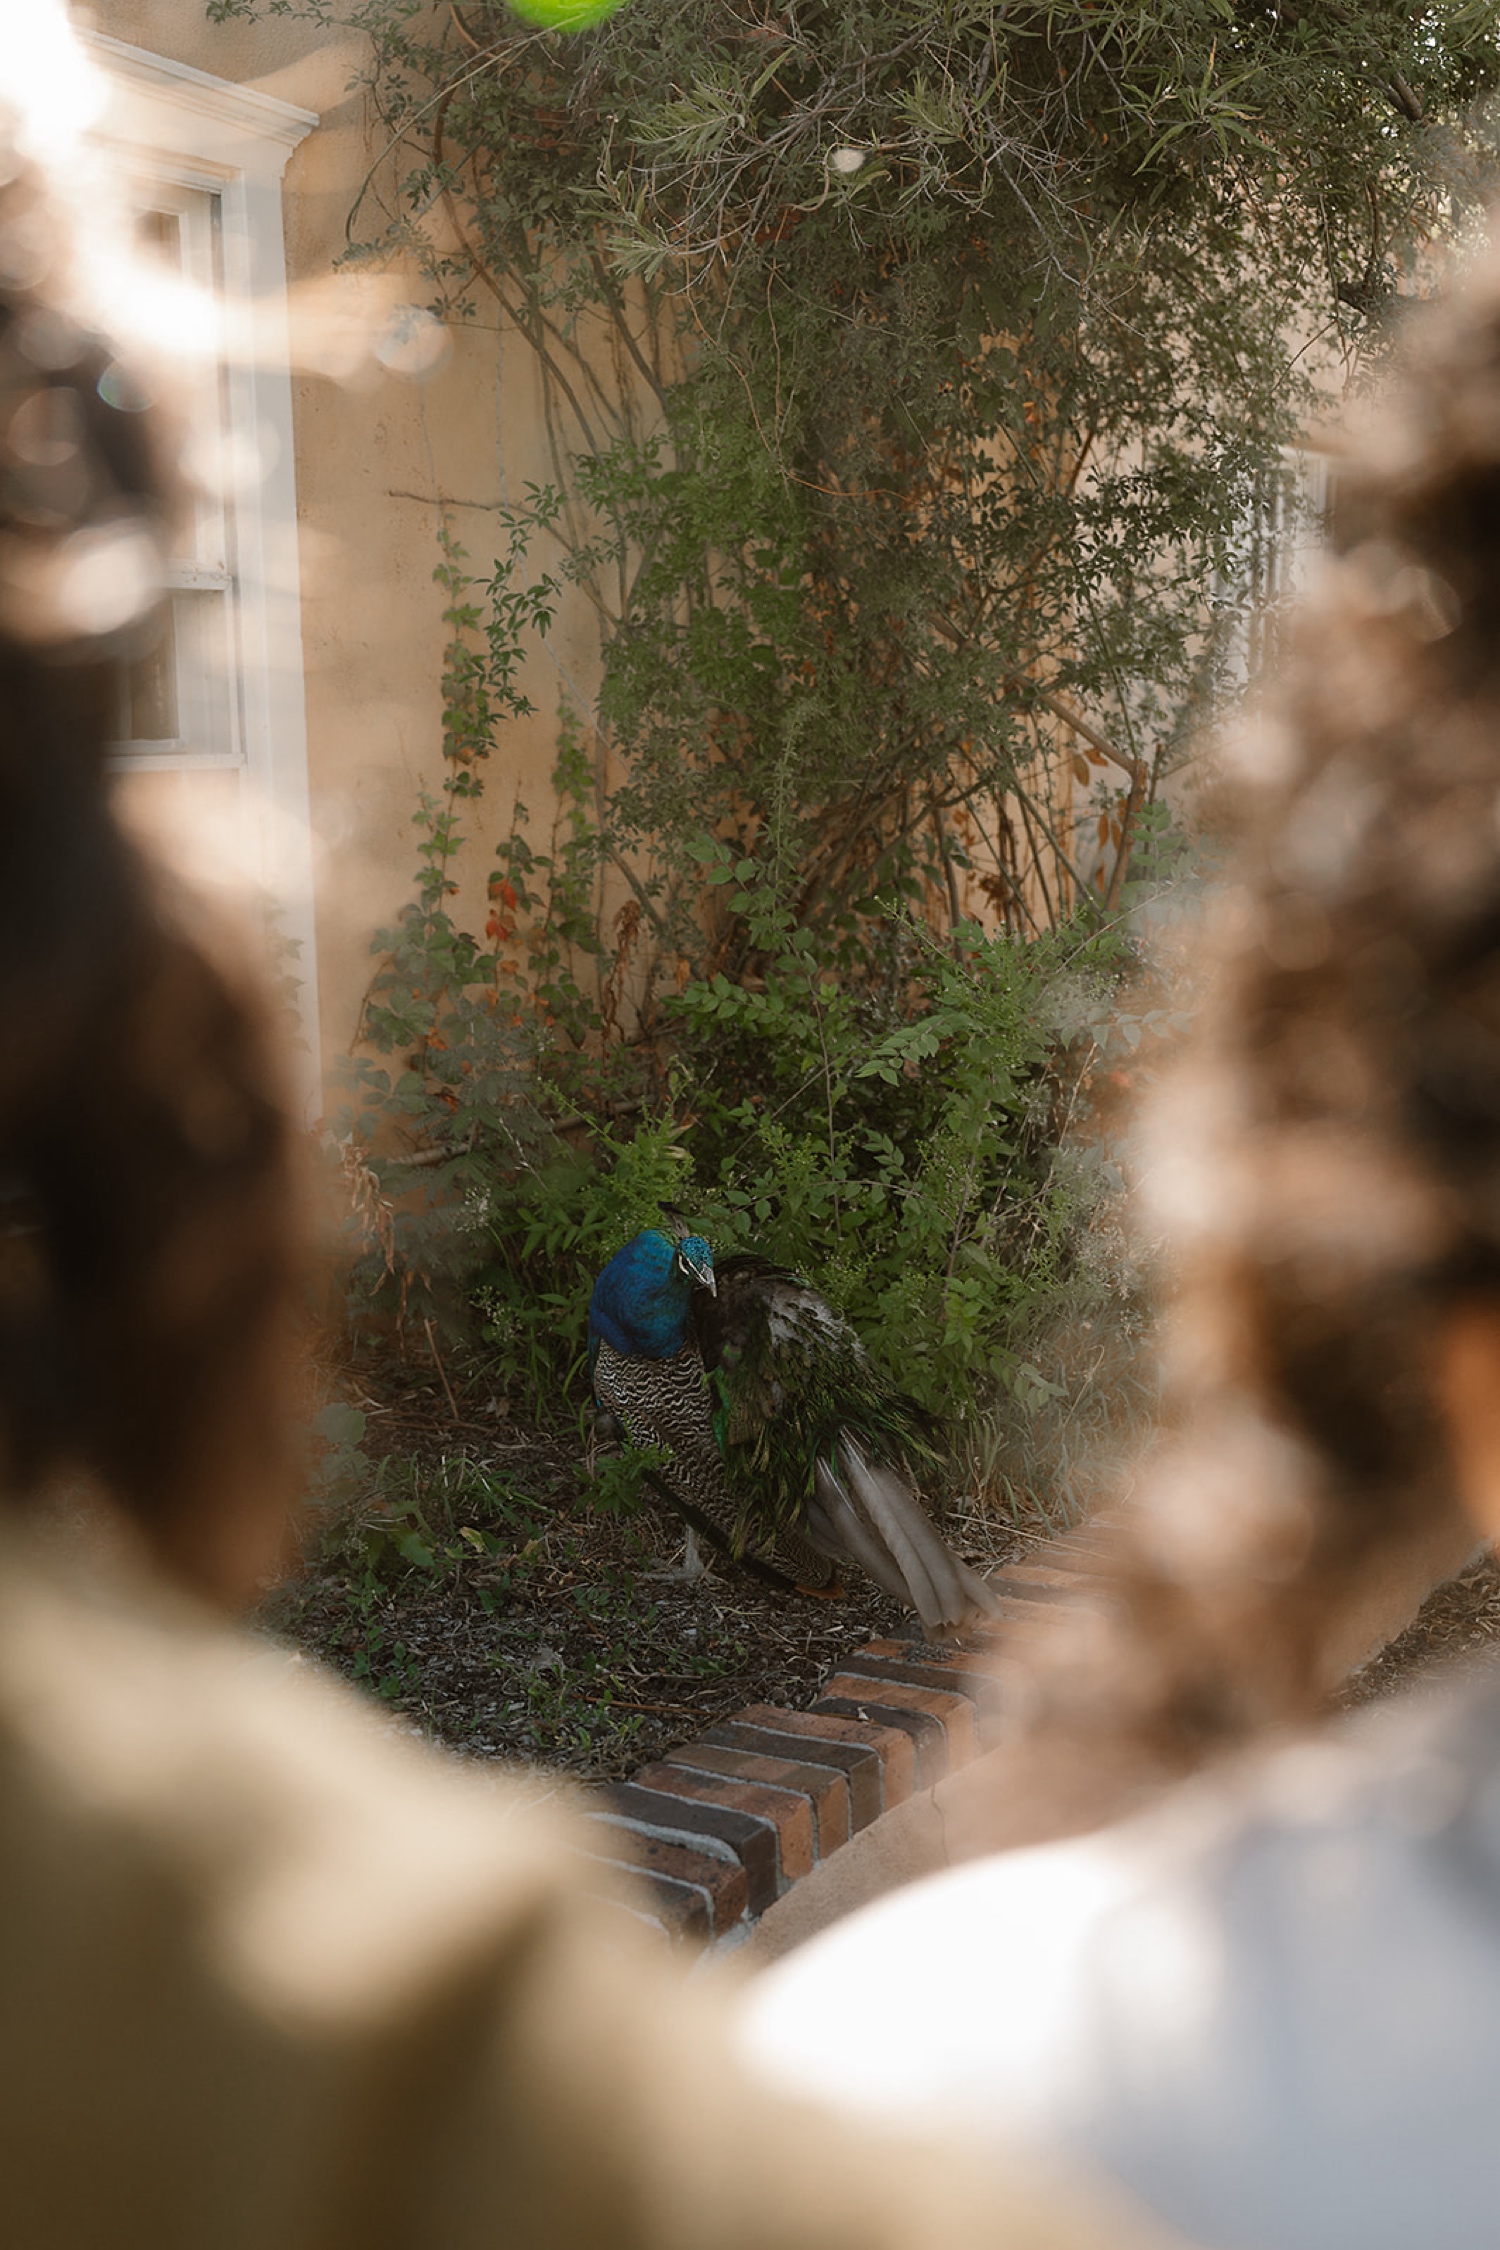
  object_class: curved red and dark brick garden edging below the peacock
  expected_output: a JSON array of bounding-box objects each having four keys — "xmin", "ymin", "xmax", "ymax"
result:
[{"xmin": 571, "ymin": 1537, "xmax": 1091, "ymax": 1946}]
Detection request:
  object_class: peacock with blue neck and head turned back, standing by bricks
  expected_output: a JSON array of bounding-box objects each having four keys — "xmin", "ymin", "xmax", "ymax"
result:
[{"xmin": 589, "ymin": 1224, "xmax": 994, "ymax": 1638}]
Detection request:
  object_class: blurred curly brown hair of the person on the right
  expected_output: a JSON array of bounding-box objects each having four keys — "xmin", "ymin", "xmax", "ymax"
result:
[{"xmin": 1038, "ymin": 241, "xmax": 1500, "ymax": 1762}]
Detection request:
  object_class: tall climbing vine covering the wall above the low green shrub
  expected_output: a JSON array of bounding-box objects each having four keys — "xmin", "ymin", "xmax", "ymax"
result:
[{"xmin": 218, "ymin": 0, "xmax": 1500, "ymax": 985}]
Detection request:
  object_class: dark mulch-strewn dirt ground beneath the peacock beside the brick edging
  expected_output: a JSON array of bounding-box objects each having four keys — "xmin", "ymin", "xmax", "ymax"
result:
[{"xmin": 261, "ymin": 1368, "xmax": 1500, "ymax": 1780}]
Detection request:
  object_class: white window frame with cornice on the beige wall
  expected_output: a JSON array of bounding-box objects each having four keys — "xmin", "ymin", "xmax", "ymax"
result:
[{"xmin": 85, "ymin": 32, "xmax": 322, "ymax": 1116}]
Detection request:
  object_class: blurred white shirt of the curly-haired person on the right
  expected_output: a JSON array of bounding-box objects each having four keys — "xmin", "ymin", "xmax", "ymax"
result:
[{"xmin": 742, "ymin": 1674, "xmax": 1500, "ymax": 2250}]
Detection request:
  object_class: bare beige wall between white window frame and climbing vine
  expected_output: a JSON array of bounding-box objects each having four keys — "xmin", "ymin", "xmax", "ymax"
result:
[{"xmin": 94, "ymin": 0, "xmax": 598, "ymax": 1111}]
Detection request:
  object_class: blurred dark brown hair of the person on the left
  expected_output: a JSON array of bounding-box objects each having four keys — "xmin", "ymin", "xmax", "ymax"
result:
[{"xmin": 0, "ymin": 140, "xmax": 297, "ymax": 1593}]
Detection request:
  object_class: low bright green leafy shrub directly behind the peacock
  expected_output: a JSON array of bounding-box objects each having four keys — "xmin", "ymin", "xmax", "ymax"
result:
[{"xmin": 461, "ymin": 837, "xmax": 1160, "ymax": 1514}]
